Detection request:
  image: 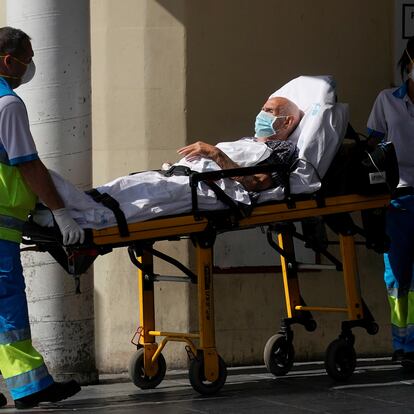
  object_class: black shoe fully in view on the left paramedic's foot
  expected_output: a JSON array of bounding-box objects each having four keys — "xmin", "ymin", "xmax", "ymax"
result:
[{"xmin": 14, "ymin": 380, "xmax": 81, "ymax": 410}]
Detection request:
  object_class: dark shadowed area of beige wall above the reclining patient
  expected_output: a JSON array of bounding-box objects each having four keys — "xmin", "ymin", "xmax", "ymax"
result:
[{"xmin": 157, "ymin": 0, "xmax": 392, "ymax": 139}]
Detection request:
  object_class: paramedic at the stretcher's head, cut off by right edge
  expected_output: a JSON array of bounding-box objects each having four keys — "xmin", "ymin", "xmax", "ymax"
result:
[{"xmin": 367, "ymin": 37, "xmax": 414, "ymax": 368}]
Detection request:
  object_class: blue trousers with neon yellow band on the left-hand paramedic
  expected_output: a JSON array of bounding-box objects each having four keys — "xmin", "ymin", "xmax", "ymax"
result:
[{"xmin": 0, "ymin": 240, "xmax": 53, "ymax": 399}]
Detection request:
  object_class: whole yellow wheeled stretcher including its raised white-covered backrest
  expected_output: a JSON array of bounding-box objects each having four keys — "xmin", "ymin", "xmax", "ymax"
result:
[{"xmin": 24, "ymin": 77, "xmax": 390, "ymax": 395}]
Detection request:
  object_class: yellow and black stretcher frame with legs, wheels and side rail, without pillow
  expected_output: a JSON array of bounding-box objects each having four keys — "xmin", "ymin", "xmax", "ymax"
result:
[{"xmin": 24, "ymin": 160, "xmax": 390, "ymax": 395}]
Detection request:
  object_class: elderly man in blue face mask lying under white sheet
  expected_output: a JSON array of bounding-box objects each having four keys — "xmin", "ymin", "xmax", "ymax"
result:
[{"xmin": 33, "ymin": 97, "xmax": 301, "ymax": 233}]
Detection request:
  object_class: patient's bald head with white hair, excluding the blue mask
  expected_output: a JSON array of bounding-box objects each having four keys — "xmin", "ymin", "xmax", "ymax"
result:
[{"xmin": 259, "ymin": 96, "xmax": 302, "ymax": 141}]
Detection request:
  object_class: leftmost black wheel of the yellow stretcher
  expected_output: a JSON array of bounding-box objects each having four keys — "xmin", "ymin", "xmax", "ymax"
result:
[{"xmin": 128, "ymin": 348, "xmax": 167, "ymax": 390}]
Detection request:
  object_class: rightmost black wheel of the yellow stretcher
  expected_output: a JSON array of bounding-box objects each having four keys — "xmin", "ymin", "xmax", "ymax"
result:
[{"xmin": 325, "ymin": 338, "xmax": 356, "ymax": 381}]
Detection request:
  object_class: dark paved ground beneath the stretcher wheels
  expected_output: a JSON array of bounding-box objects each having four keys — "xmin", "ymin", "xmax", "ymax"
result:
[{"xmin": 0, "ymin": 359, "xmax": 414, "ymax": 414}]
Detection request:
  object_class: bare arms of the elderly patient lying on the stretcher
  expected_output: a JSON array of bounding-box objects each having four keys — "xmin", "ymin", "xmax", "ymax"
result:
[{"xmin": 177, "ymin": 141, "xmax": 273, "ymax": 191}]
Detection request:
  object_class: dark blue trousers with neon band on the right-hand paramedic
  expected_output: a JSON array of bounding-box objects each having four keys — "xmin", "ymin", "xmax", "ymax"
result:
[{"xmin": 384, "ymin": 195, "xmax": 414, "ymax": 352}]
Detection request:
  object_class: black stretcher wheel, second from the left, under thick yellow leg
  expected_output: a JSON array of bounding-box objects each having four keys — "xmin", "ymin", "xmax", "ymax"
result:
[{"xmin": 188, "ymin": 354, "xmax": 227, "ymax": 395}]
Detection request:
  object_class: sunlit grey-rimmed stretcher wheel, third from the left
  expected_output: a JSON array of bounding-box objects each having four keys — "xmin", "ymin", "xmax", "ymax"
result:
[{"xmin": 263, "ymin": 334, "xmax": 295, "ymax": 377}]
